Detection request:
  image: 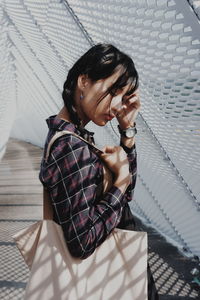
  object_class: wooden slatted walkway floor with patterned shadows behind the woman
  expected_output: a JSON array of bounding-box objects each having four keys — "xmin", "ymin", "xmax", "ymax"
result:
[{"xmin": 0, "ymin": 139, "xmax": 200, "ymax": 300}]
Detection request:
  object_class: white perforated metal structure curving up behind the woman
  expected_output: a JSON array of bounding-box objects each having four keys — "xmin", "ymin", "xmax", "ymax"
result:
[{"xmin": 0, "ymin": 0, "xmax": 200, "ymax": 256}]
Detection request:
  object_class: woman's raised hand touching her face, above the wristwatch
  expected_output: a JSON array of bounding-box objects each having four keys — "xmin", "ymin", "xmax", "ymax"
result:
[{"xmin": 116, "ymin": 89, "xmax": 141, "ymax": 129}]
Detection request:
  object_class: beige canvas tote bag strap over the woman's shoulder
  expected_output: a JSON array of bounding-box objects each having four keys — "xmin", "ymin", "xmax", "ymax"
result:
[{"xmin": 43, "ymin": 130, "xmax": 103, "ymax": 220}]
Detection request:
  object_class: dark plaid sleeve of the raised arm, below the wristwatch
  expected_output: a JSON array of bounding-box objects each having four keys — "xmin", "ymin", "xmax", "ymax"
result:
[{"xmin": 120, "ymin": 142, "xmax": 137, "ymax": 202}]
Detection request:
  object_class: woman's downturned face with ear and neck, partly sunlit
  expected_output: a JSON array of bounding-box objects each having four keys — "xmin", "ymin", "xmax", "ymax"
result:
[{"xmin": 76, "ymin": 72, "xmax": 130, "ymax": 126}]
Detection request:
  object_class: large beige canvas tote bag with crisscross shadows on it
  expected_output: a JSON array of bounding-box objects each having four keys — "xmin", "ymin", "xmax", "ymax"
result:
[{"xmin": 13, "ymin": 132, "xmax": 147, "ymax": 300}]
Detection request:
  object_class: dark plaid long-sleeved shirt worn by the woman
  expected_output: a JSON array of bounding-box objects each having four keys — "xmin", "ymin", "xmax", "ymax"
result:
[{"xmin": 39, "ymin": 116, "xmax": 136, "ymax": 258}]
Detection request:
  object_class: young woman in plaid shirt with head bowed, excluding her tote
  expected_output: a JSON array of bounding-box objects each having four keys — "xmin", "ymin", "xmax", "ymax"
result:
[{"xmin": 40, "ymin": 44, "xmax": 157, "ymax": 299}]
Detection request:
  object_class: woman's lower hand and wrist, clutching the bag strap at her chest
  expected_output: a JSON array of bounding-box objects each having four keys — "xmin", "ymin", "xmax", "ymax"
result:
[{"xmin": 101, "ymin": 146, "xmax": 131, "ymax": 192}]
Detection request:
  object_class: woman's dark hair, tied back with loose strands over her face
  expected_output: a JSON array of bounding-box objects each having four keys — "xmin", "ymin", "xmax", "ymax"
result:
[{"xmin": 62, "ymin": 44, "xmax": 138, "ymax": 125}]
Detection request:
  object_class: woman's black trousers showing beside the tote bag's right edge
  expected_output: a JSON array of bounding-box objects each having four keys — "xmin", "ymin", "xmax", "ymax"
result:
[{"xmin": 117, "ymin": 204, "xmax": 159, "ymax": 300}]
